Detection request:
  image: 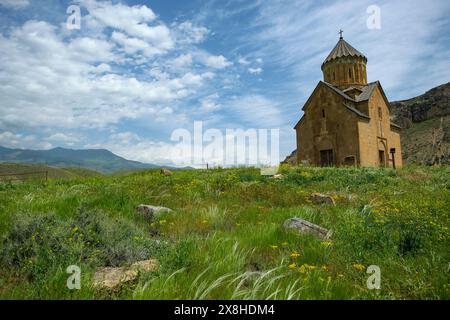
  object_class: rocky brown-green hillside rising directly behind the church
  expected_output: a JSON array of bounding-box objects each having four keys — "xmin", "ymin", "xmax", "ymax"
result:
[{"xmin": 283, "ymin": 82, "xmax": 450, "ymax": 165}]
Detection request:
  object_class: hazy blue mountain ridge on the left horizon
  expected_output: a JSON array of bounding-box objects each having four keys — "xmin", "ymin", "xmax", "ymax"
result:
[{"xmin": 0, "ymin": 147, "xmax": 158, "ymax": 173}]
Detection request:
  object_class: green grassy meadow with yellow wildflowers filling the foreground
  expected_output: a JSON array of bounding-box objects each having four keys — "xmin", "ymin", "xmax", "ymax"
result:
[{"xmin": 0, "ymin": 167, "xmax": 450, "ymax": 299}]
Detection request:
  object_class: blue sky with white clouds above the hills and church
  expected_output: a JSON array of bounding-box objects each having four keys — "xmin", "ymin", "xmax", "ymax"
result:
[{"xmin": 0, "ymin": 0, "xmax": 450, "ymax": 163}]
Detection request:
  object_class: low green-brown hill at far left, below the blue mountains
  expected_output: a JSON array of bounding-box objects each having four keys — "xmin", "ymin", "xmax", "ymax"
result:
[{"xmin": 0, "ymin": 162, "xmax": 100, "ymax": 181}]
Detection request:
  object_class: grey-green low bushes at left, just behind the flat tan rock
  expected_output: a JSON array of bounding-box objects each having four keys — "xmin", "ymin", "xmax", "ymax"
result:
[{"xmin": 0, "ymin": 209, "xmax": 162, "ymax": 278}]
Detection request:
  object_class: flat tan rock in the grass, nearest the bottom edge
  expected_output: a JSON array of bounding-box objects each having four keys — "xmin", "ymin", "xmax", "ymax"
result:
[{"xmin": 93, "ymin": 259, "xmax": 159, "ymax": 289}]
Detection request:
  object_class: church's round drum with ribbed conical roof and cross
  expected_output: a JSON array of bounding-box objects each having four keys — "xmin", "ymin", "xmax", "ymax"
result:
[{"xmin": 322, "ymin": 33, "xmax": 367, "ymax": 90}]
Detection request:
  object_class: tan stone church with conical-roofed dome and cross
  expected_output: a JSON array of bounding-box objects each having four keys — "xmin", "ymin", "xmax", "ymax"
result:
[{"xmin": 295, "ymin": 31, "xmax": 402, "ymax": 167}]
